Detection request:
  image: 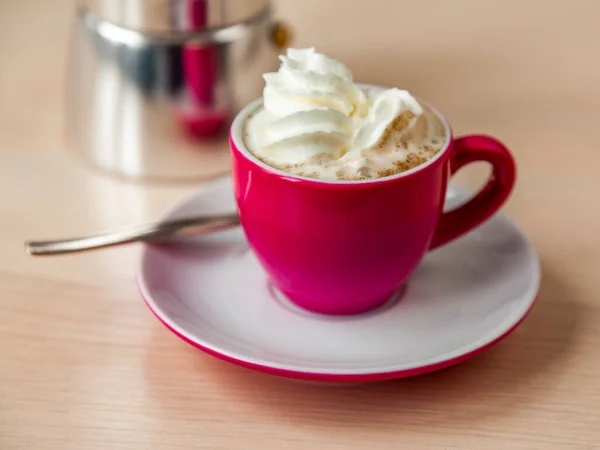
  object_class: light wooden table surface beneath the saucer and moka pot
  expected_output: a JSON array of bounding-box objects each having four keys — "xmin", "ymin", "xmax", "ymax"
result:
[{"xmin": 0, "ymin": 0, "xmax": 600, "ymax": 450}]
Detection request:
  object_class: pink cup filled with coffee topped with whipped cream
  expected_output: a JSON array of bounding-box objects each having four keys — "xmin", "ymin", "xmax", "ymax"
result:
[{"xmin": 230, "ymin": 49, "xmax": 515, "ymax": 314}]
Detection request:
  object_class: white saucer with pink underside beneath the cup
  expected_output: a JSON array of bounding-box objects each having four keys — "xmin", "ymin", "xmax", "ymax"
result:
[{"xmin": 138, "ymin": 179, "xmax": 540, "ymax": 382}]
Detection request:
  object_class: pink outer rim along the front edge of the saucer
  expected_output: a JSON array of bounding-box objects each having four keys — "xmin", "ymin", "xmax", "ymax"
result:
[{"xmin": 141, "ymin": 275, "xmax": 539, "ymax": 383}]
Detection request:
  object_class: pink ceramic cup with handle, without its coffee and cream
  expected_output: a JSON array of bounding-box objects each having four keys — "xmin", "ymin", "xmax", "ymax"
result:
[{"xmin": 230, "ymin": 95, "xmax": 515, "ymax": 314}]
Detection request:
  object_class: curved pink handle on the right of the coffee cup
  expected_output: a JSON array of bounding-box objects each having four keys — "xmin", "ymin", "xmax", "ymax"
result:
[{"xmin": 429, "ymin": 135, "xmax": 516, "ymax": 250}]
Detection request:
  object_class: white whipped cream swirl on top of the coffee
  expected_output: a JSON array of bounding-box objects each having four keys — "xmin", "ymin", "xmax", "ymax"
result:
[{"xmin": 247, "ymin": 48, "xmax": 423, "ymax": 170}]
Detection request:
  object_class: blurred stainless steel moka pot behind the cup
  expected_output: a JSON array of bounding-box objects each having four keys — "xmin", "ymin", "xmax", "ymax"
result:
[{"xmin": 67, "ymin": 0, "xmax": 288, "ymax": 180}]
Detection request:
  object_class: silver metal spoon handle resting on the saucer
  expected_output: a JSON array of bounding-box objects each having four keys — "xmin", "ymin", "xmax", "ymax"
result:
[{"xmin": 25, "ymin": 214, "xmax": 240, "ymax": 256}]
